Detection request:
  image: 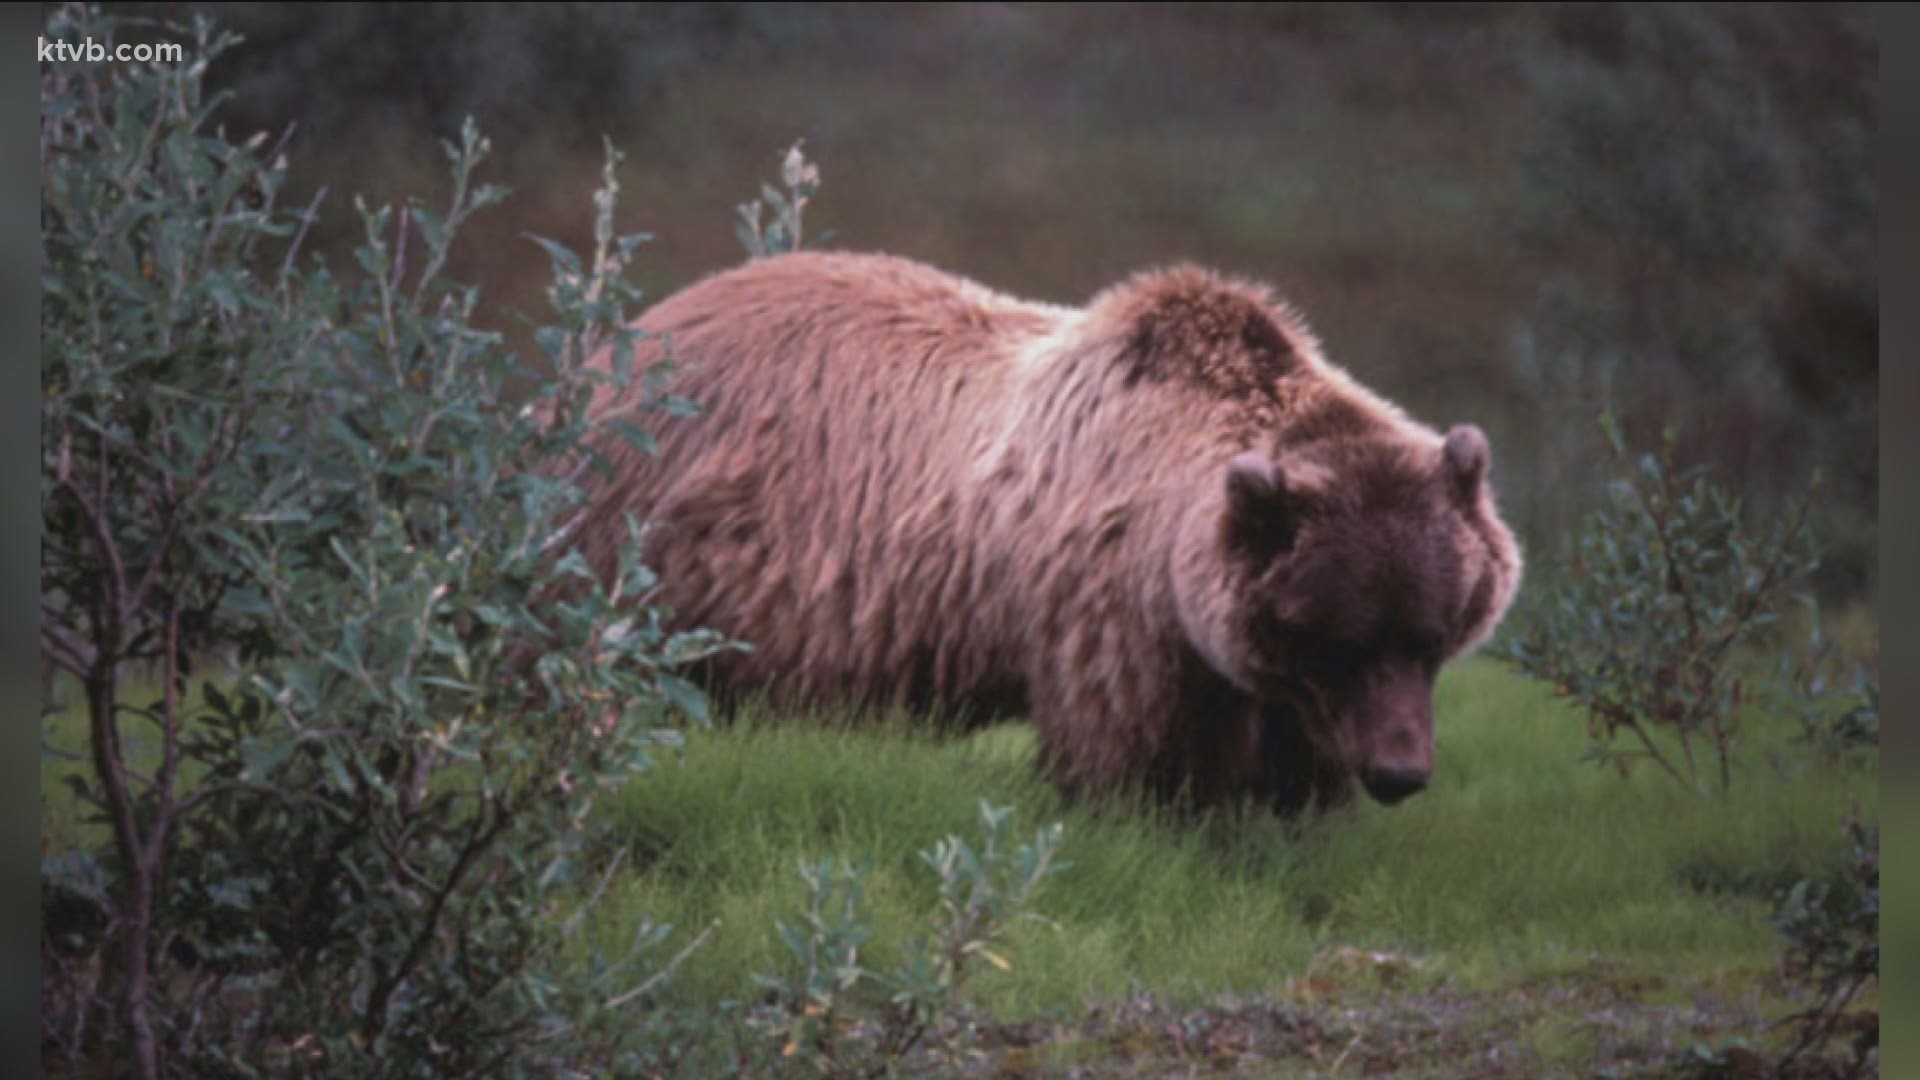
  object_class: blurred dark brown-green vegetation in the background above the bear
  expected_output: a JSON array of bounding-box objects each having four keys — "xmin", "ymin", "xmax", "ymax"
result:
[{"xmin": 116, "ymin": 4, "xmax": 1878, "ymax": 598}]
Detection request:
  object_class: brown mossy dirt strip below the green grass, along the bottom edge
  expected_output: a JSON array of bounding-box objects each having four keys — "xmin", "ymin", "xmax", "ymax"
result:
[{"xmin": 954, "ymin": 974, "xmax": 1878, "ymax": 1078}]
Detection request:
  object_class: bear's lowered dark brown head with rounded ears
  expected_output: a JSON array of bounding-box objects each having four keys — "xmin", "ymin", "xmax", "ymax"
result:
[{"xmin": 1173, "ymin": 425, "xmax": 1521, "ymax": 803}]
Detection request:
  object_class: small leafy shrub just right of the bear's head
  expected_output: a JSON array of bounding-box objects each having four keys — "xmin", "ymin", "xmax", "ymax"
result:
[{"xmin": 1501, "ymin": 415, "xmax": 1818, "ymax": 792}]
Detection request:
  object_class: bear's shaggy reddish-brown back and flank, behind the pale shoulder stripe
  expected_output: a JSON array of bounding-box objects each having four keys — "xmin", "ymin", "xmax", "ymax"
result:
[{"xmin": 593, "ymin": 254, "xmax": 1071, "ymax": 707}]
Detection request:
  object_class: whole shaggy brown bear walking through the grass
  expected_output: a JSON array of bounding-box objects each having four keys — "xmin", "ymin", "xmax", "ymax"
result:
[{"xmin": 568, "ymin": 254, "xmax": 1521, "ymax": 809}]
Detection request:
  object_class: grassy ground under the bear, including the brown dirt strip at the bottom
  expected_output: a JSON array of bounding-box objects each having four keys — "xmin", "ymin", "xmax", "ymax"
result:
[{"xmin": 42, "ymin": 661, "xmax": 1878, "ymax": 1076}]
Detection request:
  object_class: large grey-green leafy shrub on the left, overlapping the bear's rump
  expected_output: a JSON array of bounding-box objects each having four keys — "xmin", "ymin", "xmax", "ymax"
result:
[{"xmin": 40, "ymin": 10, "xmax": 722, "ymax": 1076}]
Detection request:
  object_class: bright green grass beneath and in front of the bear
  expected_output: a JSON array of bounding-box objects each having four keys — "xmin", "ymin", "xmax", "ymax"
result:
[{"xmin": 572, "ymin": 661, "xmax": 1876, "ymax": 1019}]
